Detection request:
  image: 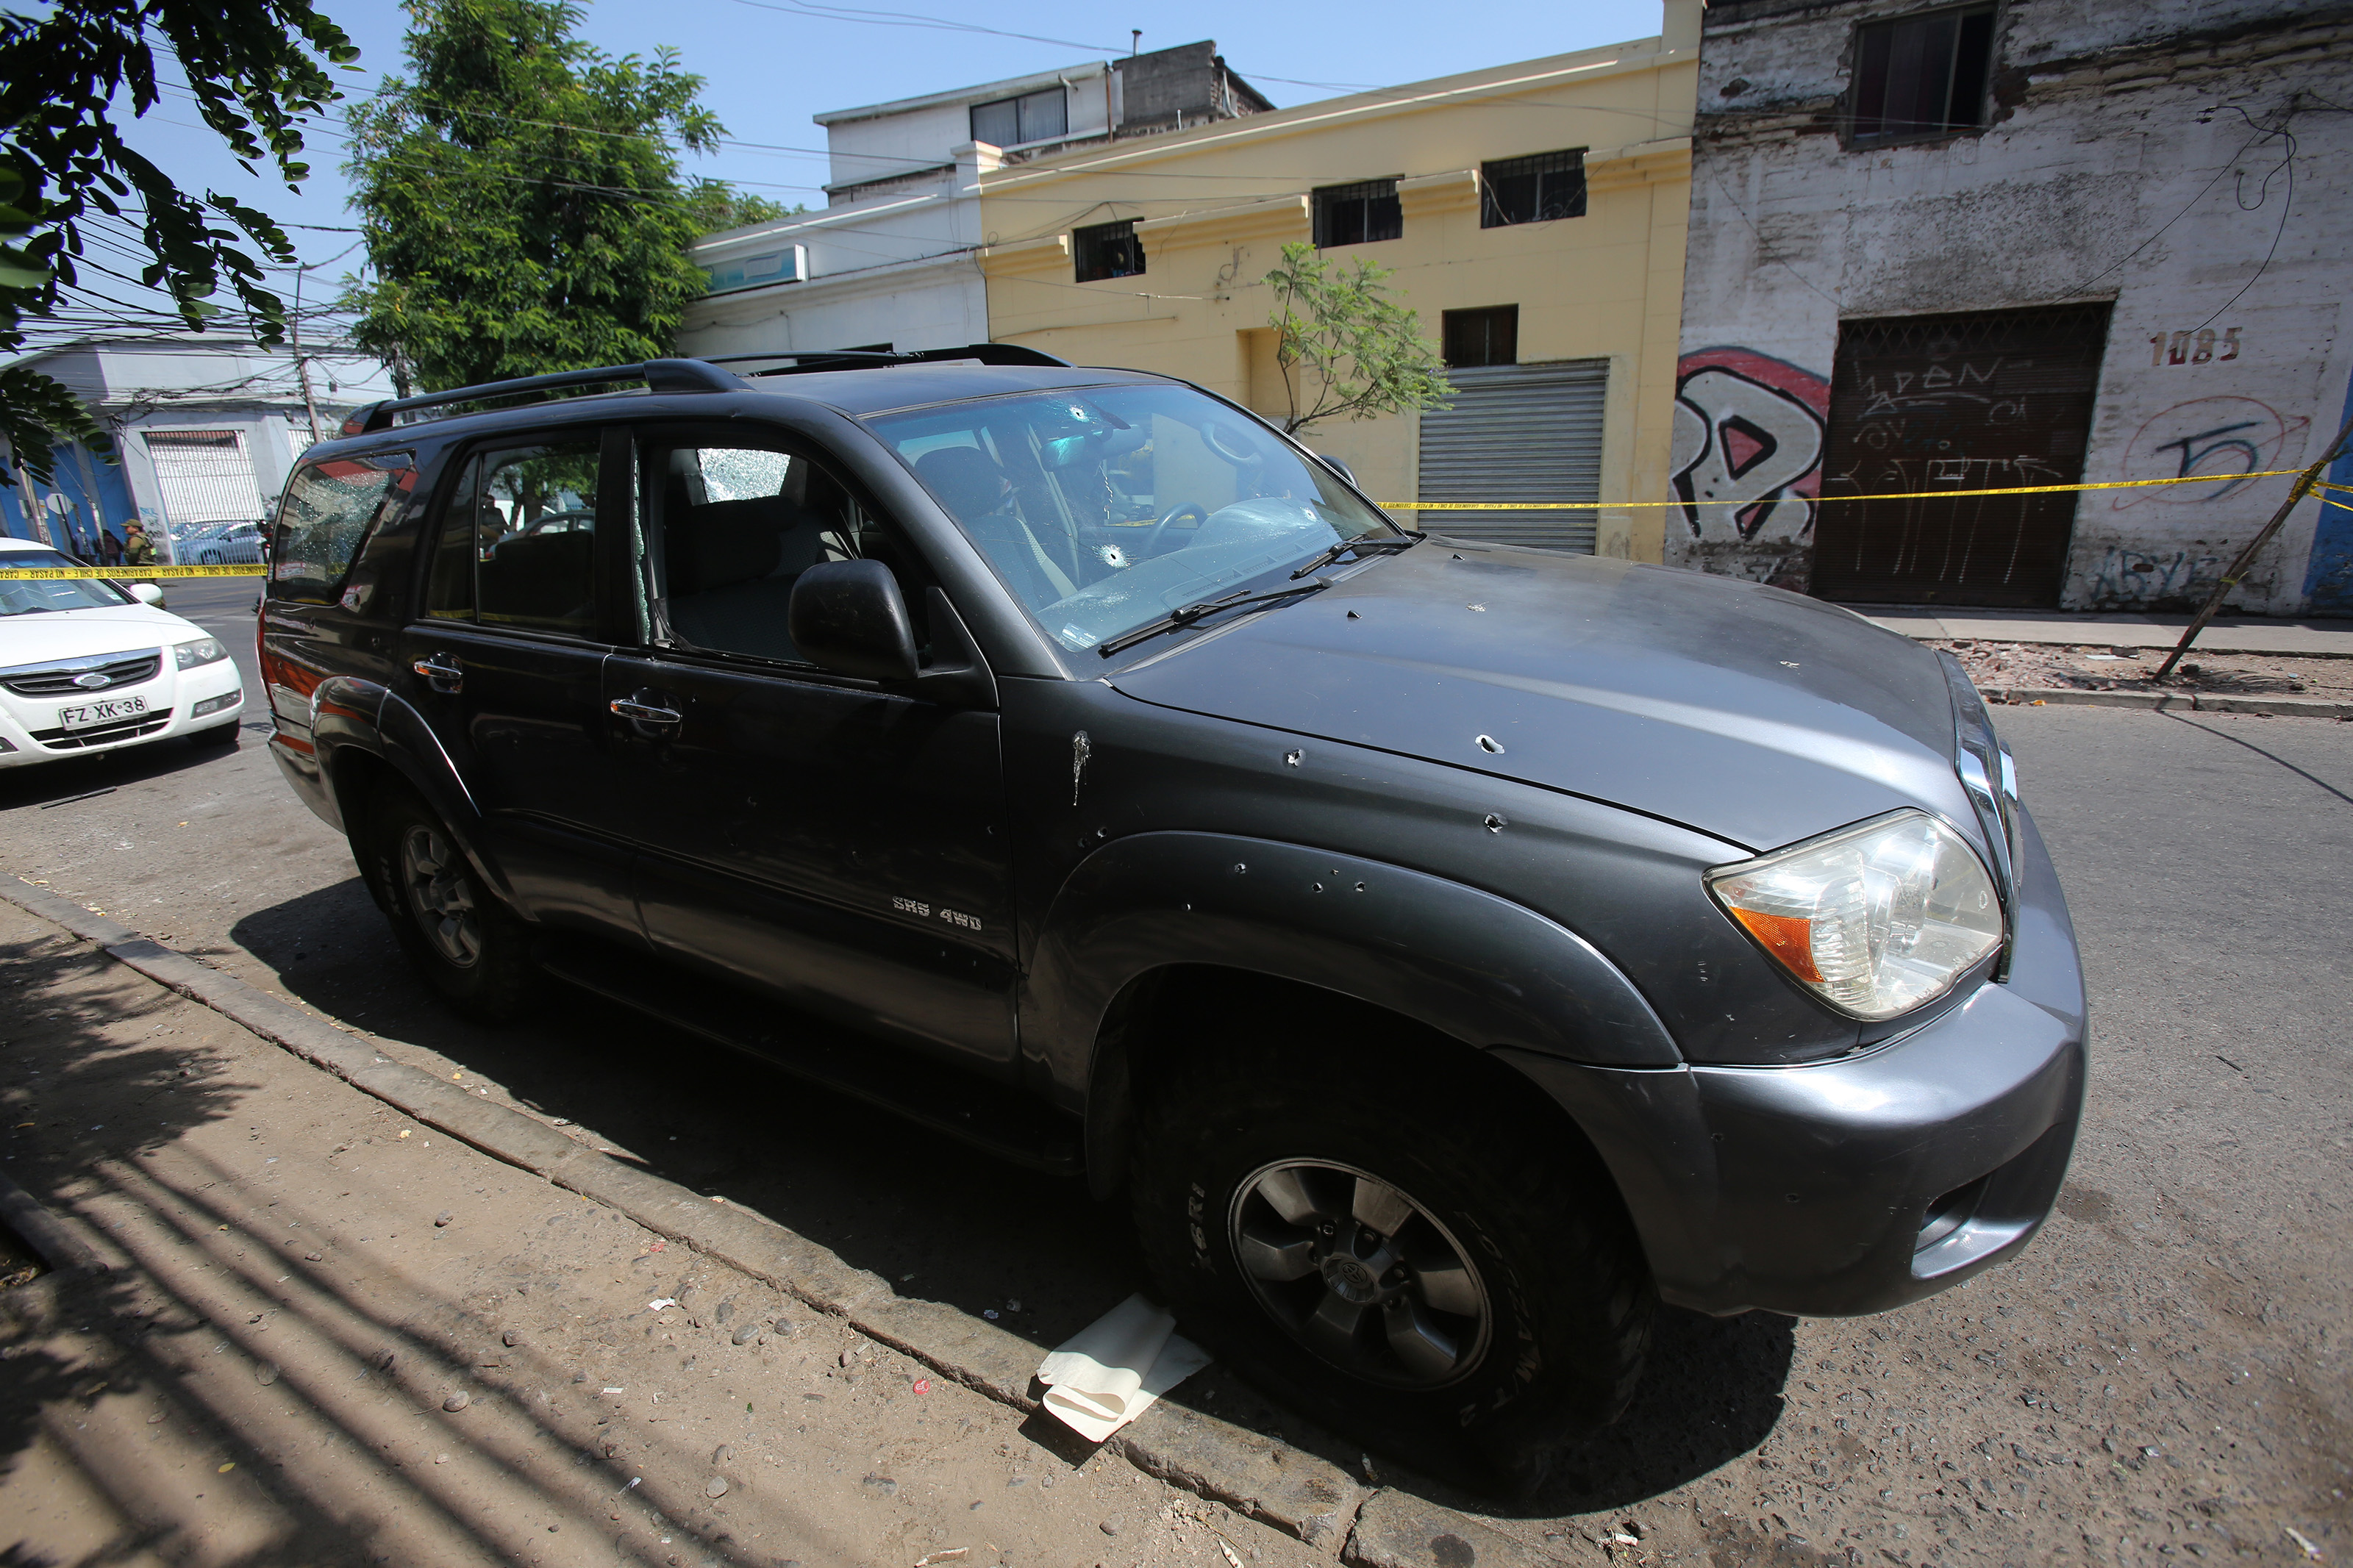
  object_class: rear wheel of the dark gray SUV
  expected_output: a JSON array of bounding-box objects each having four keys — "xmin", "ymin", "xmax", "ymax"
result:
[{"xmin": 367, "ymin": 785, "xmax": 537, "ymax": 1023}]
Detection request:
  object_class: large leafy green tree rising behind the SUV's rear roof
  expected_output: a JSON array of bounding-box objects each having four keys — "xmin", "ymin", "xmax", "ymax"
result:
[{"xmin": 346, "ymin": 0, "xmax": 781, "ymax": 390}]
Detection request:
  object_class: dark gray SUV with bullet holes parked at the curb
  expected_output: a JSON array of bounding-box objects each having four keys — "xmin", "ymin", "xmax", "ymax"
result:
[{"xmin": 261, "ymin": 346, "xmax": 2085, "ymax": 1472}]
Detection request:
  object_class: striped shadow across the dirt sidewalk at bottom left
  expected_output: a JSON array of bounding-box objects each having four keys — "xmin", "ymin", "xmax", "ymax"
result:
[{"xmin": 0, "ymin": 938, "xmax": 885, "ymax": 1568}]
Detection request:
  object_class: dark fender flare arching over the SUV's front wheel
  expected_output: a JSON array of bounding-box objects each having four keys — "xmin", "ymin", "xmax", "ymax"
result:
[{"xmin": 1021, "ymin": 832, "xmax": 1682, "ymax": 1183}]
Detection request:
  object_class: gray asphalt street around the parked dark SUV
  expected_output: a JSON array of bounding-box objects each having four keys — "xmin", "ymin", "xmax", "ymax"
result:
[{"xmin": 0, "ymin": 581, "xmax": 2353, "ymax": 1564}]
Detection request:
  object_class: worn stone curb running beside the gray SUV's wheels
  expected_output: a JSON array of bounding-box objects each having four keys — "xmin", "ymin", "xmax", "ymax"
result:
[{"xmin": 0, "ymin": 879, "xmax": 1555, "ymax": 1568}]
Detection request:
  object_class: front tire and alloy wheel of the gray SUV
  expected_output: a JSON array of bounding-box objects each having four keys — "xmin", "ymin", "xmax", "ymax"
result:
[{"xmin": 1132, "ymin": 999, "xmax": 1654, "ymax": 1490}]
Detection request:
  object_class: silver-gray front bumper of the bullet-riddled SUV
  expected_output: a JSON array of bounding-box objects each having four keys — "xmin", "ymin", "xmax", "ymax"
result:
[{"xmin": 1499, "ymin": 818, "xmax": 2085, "ymax": 1317}]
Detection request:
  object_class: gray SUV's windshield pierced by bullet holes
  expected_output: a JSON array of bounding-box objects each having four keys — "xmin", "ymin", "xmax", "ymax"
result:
[{"xmin": 871, "ymin": 385, "xmax": 1404, "ymax": 651}]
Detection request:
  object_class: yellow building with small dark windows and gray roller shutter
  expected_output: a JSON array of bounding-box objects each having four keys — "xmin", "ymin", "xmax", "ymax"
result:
[{"xmin": 981, "ymin": 0, "xmax": 1702, "ymax": 562}]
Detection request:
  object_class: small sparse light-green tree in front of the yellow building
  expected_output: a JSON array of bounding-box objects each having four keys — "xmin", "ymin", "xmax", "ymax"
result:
[{"xmin": 1263, "ymin": 240, "xmax": 1454, "ymax": 435}]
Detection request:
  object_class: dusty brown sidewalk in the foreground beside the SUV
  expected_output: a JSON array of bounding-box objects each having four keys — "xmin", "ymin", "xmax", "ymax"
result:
[{"xmin": 0, "ymin": 893, "xmax": 1365, "ymax": 1568}]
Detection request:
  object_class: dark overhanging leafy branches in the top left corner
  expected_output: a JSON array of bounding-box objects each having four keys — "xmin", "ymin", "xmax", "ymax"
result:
[{"xmin": 0, "ymin": 0, "xmax": 360, "ymax": 484}]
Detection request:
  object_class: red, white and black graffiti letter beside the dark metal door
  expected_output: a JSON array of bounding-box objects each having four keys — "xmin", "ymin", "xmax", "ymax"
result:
[{"xmin": 1671, "ymin": 348, "xmax": 1831, "ymax": 541}]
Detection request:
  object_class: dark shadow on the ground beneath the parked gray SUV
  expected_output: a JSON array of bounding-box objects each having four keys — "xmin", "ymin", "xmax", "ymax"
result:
[{"xmin": 216, "ymin": 877, "xmax": 1793, "ymax": 1517}]
